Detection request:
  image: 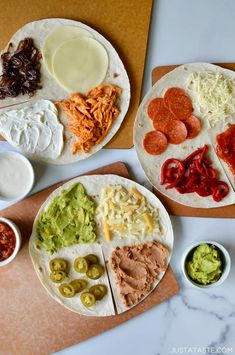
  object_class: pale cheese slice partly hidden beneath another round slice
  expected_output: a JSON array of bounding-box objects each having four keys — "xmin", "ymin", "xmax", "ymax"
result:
[{"xmin": 42, "ymin": 26, "xmax": 92, "ymax": 74}]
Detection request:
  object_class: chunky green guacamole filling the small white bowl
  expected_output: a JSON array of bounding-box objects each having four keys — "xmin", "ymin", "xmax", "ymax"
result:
[{"xmin": 186, "ymin": 244, "xmax": 222, "ymax": 285}]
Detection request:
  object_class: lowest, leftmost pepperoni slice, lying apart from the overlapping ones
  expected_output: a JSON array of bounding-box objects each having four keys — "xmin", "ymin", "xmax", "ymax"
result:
[{"xmin": 143, "ymin": 131, "xmax": 168, "ymax": 155}]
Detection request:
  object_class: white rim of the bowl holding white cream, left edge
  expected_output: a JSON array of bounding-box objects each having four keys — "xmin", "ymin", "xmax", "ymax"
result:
[{"xmin": 0, "ymin": 150, "xmax": 35, "ymax": 202}]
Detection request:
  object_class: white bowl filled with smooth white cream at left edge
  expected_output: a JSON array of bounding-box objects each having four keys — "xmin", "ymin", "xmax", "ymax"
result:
[{"xmin": 0, "ymin": 151, "xmax": 34, "ymax": 202}]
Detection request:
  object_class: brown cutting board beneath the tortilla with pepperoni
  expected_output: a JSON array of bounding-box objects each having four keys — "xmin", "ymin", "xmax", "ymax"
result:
[{"xmin": 152, "ymin": 63, "xmax": 235, "ymax": 218}]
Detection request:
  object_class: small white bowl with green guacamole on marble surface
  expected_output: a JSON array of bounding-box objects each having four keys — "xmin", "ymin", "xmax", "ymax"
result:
[{"xmin": 182, "ymin": 241, "xmax": 231, "ymax": 288}]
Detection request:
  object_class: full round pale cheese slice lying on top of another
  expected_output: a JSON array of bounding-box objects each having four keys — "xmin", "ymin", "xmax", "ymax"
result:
[{"xmin": 53, "ymin": 37, "xmax": 109, "ymax": 94}]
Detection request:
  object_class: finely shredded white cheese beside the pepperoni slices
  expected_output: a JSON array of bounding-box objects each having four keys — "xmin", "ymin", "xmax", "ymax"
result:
[{"xmin": 187, "ymin": 71, "xmax": 235, "ymax": 127}]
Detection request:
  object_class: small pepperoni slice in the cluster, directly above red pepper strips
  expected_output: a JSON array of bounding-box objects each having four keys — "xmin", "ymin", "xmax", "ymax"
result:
[{"xmin": 165, "ymin": 120, "xmax": 188, "ymax": 144}]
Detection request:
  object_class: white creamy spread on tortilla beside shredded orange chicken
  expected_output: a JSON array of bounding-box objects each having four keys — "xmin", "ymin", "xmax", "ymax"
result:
[{"xmin": 0, "ymin": 100, "xmax": 63, "ymax": 160}]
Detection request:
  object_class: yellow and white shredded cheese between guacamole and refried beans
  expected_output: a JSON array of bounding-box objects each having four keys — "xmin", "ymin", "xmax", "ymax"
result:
[{"xmin": 97, "ymin": 185, "xmax": 161, "ymax": 240}]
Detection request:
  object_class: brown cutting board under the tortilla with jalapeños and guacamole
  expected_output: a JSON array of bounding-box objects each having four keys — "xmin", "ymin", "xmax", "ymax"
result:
[{"xmin": 0, "ymin": 163, "xmax": 179, "ymax": 355}]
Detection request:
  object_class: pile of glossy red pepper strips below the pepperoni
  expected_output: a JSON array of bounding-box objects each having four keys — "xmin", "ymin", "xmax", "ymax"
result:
[{"xmin": 161, "ymin": 145, "xmax": 229, "ymax": 202}]
